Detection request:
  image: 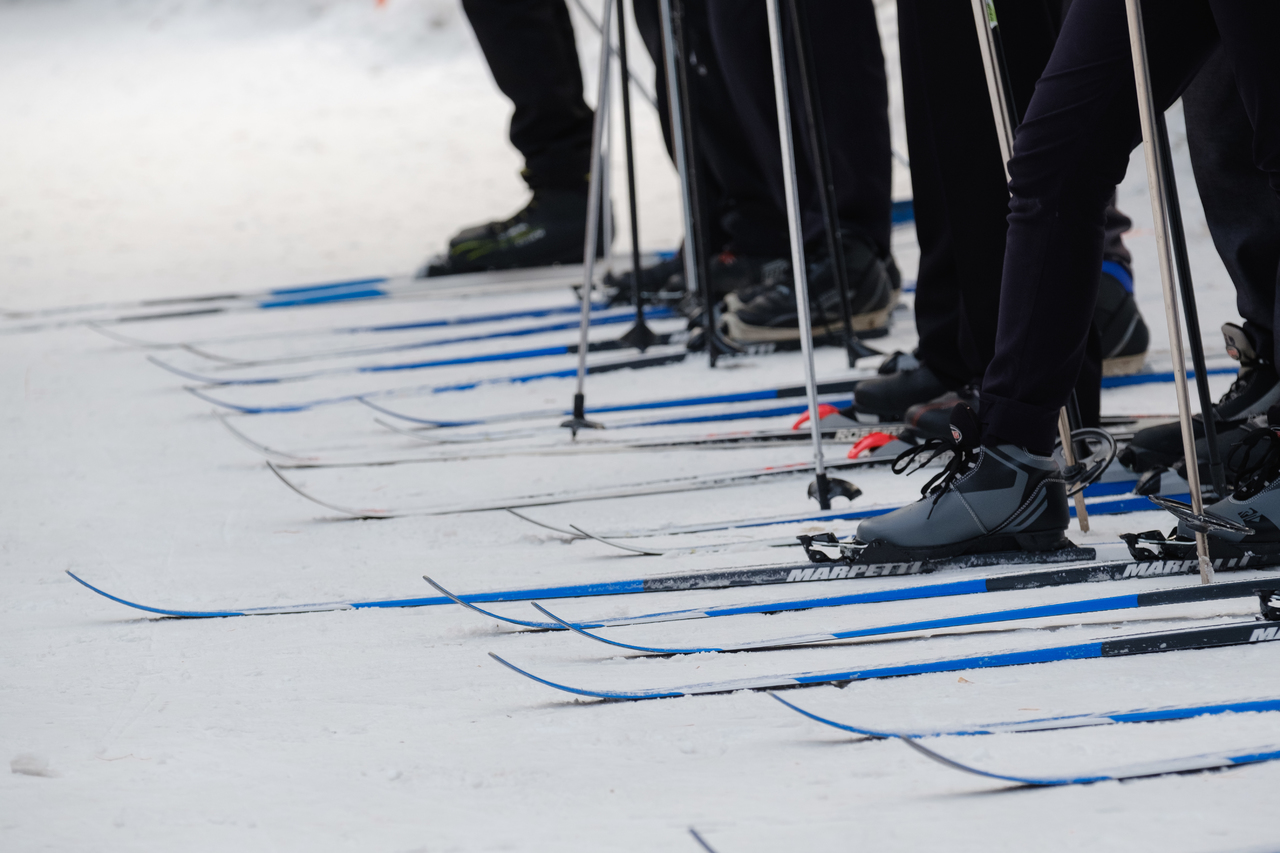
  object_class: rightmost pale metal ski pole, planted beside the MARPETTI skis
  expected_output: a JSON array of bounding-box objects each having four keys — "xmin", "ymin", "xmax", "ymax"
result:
[{"xmin": 1125, "ymin": 0, "xmax": 1213, "ymax": 584}]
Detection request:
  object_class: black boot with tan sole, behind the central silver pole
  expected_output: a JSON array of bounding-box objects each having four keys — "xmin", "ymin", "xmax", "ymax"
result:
[{"xmin": 722, "ymin": 237, "xmax": 893, "ymax": 345}]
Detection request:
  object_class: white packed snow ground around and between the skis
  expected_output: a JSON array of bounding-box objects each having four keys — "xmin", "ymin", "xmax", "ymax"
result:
[{"xmin": 0, "ymin": 0, "xmax": 1280, "ymax": 853}]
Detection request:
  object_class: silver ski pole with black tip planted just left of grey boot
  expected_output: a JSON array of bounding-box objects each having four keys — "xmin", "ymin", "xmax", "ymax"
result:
[{"xmin": 765, "ymin": 0, "xmax": 855, "ymax": 510}]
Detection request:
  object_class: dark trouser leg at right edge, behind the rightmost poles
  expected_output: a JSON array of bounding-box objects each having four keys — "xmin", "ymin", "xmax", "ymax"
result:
[{"xmin": 1183, "ymin": 49, "xmax": 1280, "ymax": 364}]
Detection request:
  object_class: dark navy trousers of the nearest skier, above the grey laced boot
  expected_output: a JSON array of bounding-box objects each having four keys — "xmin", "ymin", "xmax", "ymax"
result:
[{"xmin": 980, "ymin": 0, "xmax": 1280, "ymax": 452}]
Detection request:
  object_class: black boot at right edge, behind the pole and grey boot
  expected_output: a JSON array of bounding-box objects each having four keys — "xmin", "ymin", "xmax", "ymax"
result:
[{"xmin": 1119, "ymin": 323, "xmax": 1280, "ymax": 473}]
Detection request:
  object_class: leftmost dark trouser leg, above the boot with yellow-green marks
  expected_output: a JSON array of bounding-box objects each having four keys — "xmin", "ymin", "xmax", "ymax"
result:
[{"xmin": 462, "ymin": 0, "xmax": 594, "ymax": 191}]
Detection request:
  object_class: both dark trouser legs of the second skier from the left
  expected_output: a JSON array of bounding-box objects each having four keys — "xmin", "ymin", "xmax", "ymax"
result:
[{"xmin": 635, "ymin": 0, "xmax": 892, "ymax": 257}]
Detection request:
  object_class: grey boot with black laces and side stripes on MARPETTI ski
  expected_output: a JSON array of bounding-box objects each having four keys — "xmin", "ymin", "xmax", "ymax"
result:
[{"xmin": 858, "ymin": 403, "xmax": 1071, "ymax": 562}]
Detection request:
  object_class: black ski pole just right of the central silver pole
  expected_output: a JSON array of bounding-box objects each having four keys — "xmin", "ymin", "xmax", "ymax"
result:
[{"xmin": 787, "ymin": 0, "xmax": 876, "ymax": 368}]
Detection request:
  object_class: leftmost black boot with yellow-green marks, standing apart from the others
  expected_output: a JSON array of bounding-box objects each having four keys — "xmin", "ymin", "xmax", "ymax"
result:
[{"xmin": 420, "ymin": 188, "xmax": 586, "ymax": 277}]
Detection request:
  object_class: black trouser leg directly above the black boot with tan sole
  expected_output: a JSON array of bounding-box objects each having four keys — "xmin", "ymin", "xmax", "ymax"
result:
[{"xmin": 707, "ymin": 0, "xmax": 892, "ymax": 256}]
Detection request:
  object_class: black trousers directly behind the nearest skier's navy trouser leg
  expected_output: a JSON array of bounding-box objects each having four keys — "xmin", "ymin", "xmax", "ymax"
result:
[{"xmin": 897, "ymin": 0, "xmax": 1132, "ymax": 409}]
